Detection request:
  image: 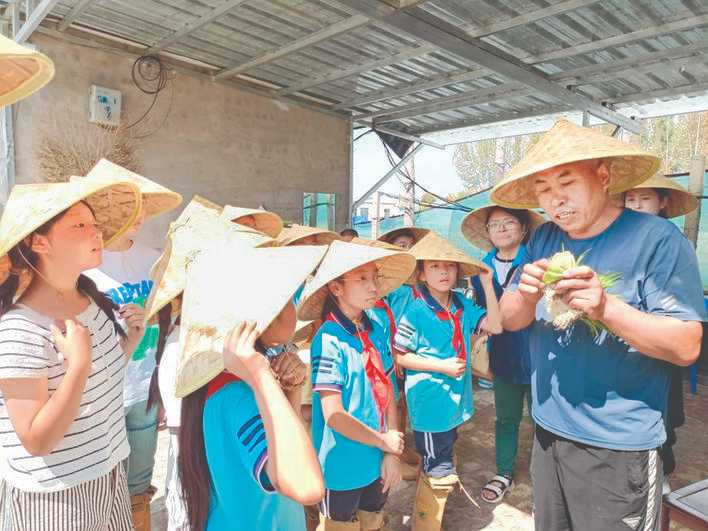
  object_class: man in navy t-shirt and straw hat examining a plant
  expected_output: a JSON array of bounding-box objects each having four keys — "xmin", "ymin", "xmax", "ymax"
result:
[{"xmin": 492, "ymin": 120, "xmax": 704, "ymax": 531}]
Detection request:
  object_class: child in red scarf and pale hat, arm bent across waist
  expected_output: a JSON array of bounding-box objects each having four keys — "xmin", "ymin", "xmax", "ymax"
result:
[{"xmin": 298, "ymin": 241, "xmax": 415, "ymax": 531}]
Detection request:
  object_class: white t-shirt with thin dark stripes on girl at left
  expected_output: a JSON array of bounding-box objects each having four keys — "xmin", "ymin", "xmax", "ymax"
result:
[{"xmin": 0, "ymin": 302, "xmax": 130, "ymax": 492}]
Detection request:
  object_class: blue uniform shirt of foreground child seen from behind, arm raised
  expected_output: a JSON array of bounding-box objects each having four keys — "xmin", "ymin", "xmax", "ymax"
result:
[{"xmin": 203, "ymin": 373, "xmax": 305, "ymax": 531}]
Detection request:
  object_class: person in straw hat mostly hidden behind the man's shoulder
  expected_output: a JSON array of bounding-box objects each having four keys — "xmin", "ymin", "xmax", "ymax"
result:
[{"xmin": 624, "ymin": 174, "xmax": 698, "ymax": 494}]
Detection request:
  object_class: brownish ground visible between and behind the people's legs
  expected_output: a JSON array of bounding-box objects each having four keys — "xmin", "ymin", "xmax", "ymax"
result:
[{"xmin": 152, "ymin": 386, "xmax": 708, "ymax": 531}]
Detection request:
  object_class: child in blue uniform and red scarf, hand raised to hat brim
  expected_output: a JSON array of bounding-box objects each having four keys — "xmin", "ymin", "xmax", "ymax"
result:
[{"xmin": 395, "ymin": 231, "xmax": 502, "ymax": 530}]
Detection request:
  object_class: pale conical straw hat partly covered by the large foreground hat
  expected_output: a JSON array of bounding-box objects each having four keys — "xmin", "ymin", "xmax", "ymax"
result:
[{"xmin": 145, "ymin": 196, "xmax": 274, "ymax": 322}]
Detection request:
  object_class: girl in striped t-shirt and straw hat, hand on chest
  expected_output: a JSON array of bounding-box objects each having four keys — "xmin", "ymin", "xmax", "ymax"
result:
[{"xmin": 0, "ymin": 178, "xmax": 144, "ymax": 531}]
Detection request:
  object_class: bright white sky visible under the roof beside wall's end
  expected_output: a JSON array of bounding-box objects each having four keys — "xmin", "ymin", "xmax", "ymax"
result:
[{"xmin": 353, "ymin": 129, "xmax": 464, "ymax": 209}]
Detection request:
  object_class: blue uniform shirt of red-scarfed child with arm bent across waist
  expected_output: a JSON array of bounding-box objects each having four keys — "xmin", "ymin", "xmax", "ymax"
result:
[{"xmin": 310, "ymin": 308, "xmax": 393, "ymax": 491}]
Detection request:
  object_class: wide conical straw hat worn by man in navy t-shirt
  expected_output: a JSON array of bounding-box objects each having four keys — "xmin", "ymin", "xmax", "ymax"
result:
[{"xmin": 491, "ymin": 119, "xmax": 660, "ymax": 208}]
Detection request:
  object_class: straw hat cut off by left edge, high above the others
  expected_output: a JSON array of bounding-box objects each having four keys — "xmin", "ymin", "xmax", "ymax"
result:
[{"xmin": 0, "ymin": 35, "xmax": 54, "ymax": 107}]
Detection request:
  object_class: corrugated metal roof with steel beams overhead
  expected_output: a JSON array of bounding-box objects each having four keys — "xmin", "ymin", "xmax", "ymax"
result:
[{"xmin": 0, "ymin": 0, "xmax": 708, "ymax": 134}]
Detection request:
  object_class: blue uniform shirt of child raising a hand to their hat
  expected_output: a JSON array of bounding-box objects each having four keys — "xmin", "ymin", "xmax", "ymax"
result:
[{"xmin": 395, "ymin": 284, "xmax": 486, "ymax": 433}]
